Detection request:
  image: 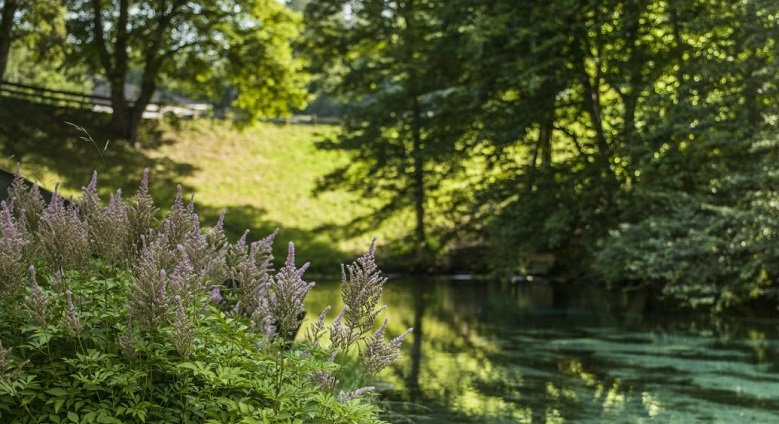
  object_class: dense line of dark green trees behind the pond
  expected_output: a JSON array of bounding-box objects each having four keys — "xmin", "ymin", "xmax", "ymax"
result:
[{"xmin": 305, "ymin": 0, "xmax": 779, "ymax": 306}]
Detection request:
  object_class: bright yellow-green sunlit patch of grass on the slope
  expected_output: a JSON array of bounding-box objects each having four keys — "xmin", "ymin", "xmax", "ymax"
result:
[{"xmin": 143, "ymin": 124, "xmax": 378, "ymax": 273}]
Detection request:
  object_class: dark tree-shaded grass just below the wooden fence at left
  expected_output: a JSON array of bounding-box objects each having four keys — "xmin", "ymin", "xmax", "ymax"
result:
[{"xmin": 0, "ymin": 98, "xmax": 197, "ymax": 204}]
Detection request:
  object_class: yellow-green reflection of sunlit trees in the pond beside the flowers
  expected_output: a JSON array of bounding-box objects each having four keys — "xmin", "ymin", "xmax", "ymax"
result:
[{"xmin": 380, "ymin": 284, "xmax": 620, "ymax": 422}]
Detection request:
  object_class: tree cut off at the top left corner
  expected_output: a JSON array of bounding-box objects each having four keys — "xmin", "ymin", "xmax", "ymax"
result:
[{"xmin": 0, "ymin": 0, "xmax": 65, "ymax": 81}]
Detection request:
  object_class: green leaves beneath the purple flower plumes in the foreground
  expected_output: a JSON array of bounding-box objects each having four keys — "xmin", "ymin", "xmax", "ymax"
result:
[{"xmin": 0, "ymin": 170, "xmax": 402, "ymax": 424}]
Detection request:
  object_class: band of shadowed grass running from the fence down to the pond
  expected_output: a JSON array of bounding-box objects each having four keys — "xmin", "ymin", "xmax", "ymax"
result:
[{"xmin": 0, "ymin": 97, "xmax": 360, "ymax": 275}]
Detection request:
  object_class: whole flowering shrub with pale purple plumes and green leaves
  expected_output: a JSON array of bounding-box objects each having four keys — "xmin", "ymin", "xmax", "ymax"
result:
[{"xmin": 0, "ymin": 169, "xmax": 410, "ymax": 423}]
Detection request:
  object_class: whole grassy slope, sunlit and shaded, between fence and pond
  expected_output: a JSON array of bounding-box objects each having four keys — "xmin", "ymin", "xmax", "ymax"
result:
[{"xmin": 0, "ymin": 98, "xmax": 402, "ymax": 274}]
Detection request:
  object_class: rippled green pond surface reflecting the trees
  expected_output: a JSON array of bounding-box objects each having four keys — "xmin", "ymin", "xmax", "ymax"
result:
[{"xmin": 309, "ymin": 281, "xmax": 779, "ymax": 424}]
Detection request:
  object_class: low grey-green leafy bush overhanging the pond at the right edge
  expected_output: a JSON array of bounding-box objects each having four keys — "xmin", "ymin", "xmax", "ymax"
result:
[{"xmin": 594, "ymin": 134, "xmax": 779, "ymax": 309}]
